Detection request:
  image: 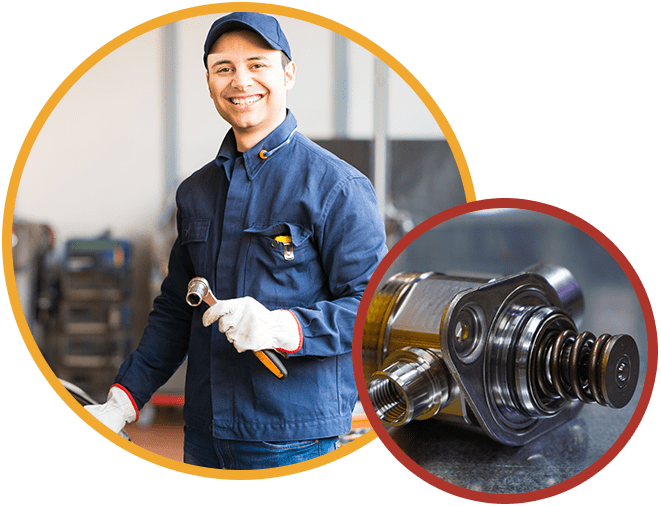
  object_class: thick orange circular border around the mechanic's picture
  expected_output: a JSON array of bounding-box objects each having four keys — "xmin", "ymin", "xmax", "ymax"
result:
[{"xmin": 2, "ymin": 2, "xmax": 475, "ymax": 480}]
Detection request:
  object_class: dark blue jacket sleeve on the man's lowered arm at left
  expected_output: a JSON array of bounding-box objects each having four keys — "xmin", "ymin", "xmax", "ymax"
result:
[{"xmin": 110, "ymin": 208, "xmax": 193, "ymax": 409}]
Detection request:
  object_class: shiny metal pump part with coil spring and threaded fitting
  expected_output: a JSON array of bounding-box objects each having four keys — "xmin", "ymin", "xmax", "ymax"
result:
[{"xmin": 363, "ymin": 264, "xmax": 639, "ymax": 445}]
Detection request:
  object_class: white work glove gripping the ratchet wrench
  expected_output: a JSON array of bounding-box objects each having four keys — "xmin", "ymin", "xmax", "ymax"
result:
[{"xmin": 202, "ymin": 297, "xmax": 303, "ymax": 353}]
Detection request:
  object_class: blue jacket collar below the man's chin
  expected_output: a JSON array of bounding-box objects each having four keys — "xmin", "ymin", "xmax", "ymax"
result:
[{"xmin": 216, "ymin": 109, "xmax": 297, "ymax": 181}]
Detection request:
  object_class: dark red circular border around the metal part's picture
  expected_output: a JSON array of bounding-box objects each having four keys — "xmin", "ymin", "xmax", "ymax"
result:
[{"xmin": 352, "ymin": 198, "xmax": 658, "ymax": 504}]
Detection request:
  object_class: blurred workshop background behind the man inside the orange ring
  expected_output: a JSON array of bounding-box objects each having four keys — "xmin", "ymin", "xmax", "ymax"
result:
[{"xmin": 13, "ymin": 14, "xmax": 466, "ymax": 460}]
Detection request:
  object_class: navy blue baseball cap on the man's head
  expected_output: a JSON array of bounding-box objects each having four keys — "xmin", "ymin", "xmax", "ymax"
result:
[{"xmin": 204, "ymin": 12, "xmax": 292, "ymax": 67}]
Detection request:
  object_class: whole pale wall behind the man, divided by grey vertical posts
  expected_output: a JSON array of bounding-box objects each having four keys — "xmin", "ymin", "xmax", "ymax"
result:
[{"xmin": 15, "ymin": 11, "xmax": 443, "ymax": 240}]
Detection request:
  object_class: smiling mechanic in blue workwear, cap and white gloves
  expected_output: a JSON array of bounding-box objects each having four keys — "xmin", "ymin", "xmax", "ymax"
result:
[{"xmin": 87, "ymin": 13, "xmax": 386, "ymax": 469}]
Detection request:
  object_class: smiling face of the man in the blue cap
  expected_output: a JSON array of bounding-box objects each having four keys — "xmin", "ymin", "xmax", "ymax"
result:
[{"xmin": 207, "ymin": 30, "xmax": 296, "ymax": 142}]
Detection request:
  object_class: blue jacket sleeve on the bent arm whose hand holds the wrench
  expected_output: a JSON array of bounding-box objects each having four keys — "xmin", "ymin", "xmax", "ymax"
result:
[{"xmin": 288, "ymin": 176, "xmax": 387, "ymax": 357}]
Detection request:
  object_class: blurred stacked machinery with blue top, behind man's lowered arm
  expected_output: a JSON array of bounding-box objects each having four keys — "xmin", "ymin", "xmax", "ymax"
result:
[{"xmin": 51, "ymin": 236, "xmax": 133, "ymax": 398}]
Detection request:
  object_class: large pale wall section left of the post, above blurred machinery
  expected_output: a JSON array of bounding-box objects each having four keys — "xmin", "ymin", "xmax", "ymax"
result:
[{"xmin": 15, "ymin": 27, "xmax": 163, "ymax": 239}]
